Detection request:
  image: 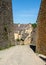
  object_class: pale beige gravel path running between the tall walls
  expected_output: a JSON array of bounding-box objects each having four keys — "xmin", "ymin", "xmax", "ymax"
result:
[{"xmin": 0, "ymin": 45, "xmax": 45, "ymax": 65}]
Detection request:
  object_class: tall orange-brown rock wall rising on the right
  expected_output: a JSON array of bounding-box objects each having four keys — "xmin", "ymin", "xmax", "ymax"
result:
[{"xmin": 36, "ymin": 0, "xmax": 46, "ymax": 55}]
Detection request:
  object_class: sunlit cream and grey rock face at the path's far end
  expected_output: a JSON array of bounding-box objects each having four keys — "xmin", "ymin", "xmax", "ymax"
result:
[{"xmin": 14, "ymin": 24, "xmax": 33, "ymax": 44}]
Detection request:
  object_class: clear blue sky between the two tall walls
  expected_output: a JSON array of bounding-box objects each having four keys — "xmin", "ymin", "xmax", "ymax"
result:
[{"xmin": 12, "ymin": 0, "xmax": 41, "ymax": 24}]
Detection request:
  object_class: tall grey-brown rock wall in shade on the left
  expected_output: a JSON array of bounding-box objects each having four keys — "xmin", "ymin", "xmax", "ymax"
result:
[{"xmin": 0, "ymin": 0, "xmax": 14, "ymax": 47}]
